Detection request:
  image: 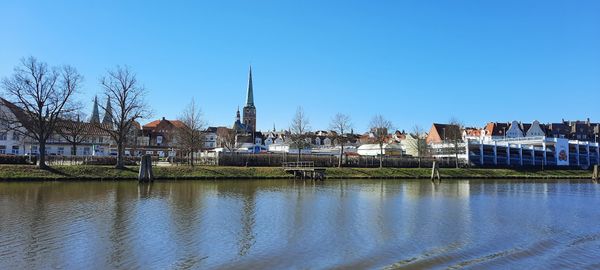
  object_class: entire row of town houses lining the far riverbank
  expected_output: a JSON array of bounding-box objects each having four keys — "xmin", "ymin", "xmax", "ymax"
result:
[{"xmin": 0, "ymin": 93, "xmax": 600, "ymax": 166}]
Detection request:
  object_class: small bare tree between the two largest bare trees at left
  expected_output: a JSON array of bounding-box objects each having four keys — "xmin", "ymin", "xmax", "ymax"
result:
[{"xmin": 56, "ymin": 110, "xmax": 89, "ymax": 156}]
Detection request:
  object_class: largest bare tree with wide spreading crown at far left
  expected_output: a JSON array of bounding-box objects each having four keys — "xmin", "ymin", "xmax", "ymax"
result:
[{"xmin": 2, "ymin": 57, "xmax": 83, "ymax": 168}]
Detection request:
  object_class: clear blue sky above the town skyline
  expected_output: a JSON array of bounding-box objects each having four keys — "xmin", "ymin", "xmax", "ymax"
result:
[{"xmin": 0, "ymin": 0, "xmax": 600, "ymax": 131}]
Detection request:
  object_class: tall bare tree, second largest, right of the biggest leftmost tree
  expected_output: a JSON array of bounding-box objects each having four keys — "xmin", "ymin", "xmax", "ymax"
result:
[{"xmin": 98, "ymin": 66, "xmax": 151, "ymax": 169}]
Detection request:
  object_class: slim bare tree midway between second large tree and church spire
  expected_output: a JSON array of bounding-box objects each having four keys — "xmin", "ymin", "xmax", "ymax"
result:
[{"xmin": 176, "ymin": 99, "xmax": 206, "ymax": 167}]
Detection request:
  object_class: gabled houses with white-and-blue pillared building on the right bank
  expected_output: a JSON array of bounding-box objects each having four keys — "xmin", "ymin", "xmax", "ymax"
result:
[{"xmin": 427, "ymin": 119, "xmax": 600, "ymax": 167}]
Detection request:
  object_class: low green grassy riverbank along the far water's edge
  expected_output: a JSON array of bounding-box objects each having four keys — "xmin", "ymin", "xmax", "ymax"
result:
[{"xmin": 0, "ymin": 165, "xmax": 591, "ymax": 181}]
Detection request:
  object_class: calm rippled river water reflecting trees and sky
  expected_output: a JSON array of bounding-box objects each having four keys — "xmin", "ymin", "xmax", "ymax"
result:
[{"xmin": 0, "ymin": 180, "xmax": 600, "ymax": 269}]
